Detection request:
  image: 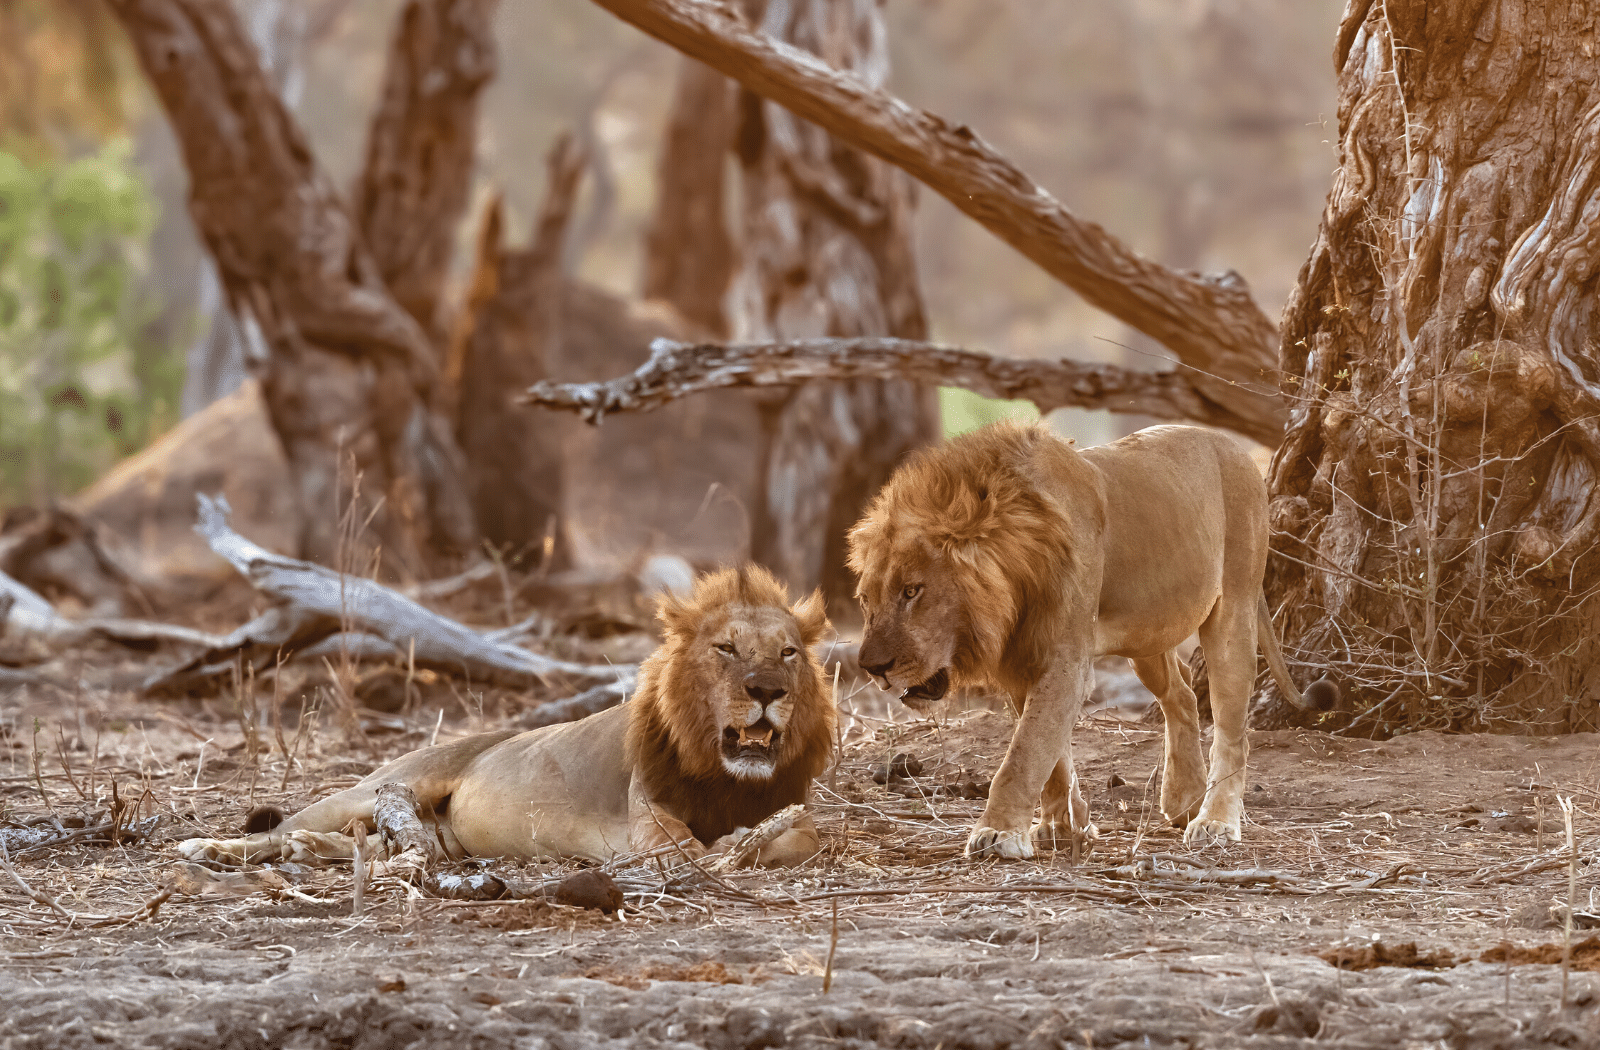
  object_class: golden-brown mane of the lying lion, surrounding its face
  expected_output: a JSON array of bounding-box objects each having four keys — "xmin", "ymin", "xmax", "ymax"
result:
[{"xmin": 627, "ymin": 565, "xmax": 835, "ymax": 844}]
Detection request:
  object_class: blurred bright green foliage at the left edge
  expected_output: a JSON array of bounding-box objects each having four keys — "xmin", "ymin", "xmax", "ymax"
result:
[{"xmin": 0, "ymin": 142, "xmax": 182, "ymax": 506}]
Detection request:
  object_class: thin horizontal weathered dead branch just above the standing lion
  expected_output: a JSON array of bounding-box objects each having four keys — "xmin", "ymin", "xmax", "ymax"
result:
[{"xmin": 522, "ymin": 338, "xmax": 1250, "ymax": 434}]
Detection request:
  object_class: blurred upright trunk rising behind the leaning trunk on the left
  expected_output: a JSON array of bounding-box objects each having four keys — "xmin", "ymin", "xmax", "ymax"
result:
[{"xmin": 350, "ymin": 0, "xmax": 496, "ymax": 346}]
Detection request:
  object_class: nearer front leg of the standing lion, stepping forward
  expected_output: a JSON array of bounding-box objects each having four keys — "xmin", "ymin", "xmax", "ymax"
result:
[{"xmin": 966, "ymin": 650, "xmax": 1093, "ymax": 860}]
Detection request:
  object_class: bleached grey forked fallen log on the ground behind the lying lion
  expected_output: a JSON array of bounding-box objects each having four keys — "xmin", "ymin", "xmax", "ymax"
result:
[{"xmin": 146, "ymin": 495, "xmax": 632, "ymax": 691}]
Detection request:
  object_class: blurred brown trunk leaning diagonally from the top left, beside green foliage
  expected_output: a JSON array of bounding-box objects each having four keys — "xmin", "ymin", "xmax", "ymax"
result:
[{"xmin": 112, "ymin": 0, "xmax": 474, "ymax": 573}]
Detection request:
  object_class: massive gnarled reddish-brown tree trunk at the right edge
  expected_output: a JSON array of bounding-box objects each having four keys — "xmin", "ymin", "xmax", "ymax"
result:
[{"xmin": 1269, "ymin": 0, "xmax": 1600, "ymax": 731}]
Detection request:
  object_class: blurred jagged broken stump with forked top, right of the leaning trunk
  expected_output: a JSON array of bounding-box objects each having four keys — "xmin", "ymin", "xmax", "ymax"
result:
[{"xmin": 450, "ymin": 138, "xmax": 586, "ymax": 557}]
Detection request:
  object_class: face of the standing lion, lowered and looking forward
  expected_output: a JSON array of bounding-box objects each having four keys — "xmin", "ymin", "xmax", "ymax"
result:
[{"xmin": 858, "ymin": 543, "xmax": 971, "ymax": 711}]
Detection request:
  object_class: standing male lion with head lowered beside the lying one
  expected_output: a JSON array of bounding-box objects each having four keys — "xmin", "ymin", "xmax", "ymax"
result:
[{"xmin": 848, "ymin": 423, "xmax": 1306, "ymax": 860}]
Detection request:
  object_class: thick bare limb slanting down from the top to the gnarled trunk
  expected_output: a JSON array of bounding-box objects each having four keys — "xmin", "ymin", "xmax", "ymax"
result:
[{"xmin": 576, "ymin": 0, "xmax": 1286, "ymax": 445}]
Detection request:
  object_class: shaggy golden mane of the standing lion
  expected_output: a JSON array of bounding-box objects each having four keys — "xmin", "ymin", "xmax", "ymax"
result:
[{"xmin": 850, "ymin": 423, "xmax": 1077, "ymax": 695}]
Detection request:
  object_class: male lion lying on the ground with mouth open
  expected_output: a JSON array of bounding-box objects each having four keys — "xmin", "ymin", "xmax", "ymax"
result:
[{"xmin": 179, "ymin": 568, "xmax": 835, "ymax": 864}]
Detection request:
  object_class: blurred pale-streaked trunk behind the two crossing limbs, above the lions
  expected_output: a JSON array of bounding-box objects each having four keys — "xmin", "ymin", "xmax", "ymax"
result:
[{"xmin": 730, "ymin": 0, "xmax": 939, "ymax": 615}]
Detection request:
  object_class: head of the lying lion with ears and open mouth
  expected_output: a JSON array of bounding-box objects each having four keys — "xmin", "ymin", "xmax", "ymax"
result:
[{"xmin": 646, "ymin": 570, "xmax": 832, "ymax": 781}]
